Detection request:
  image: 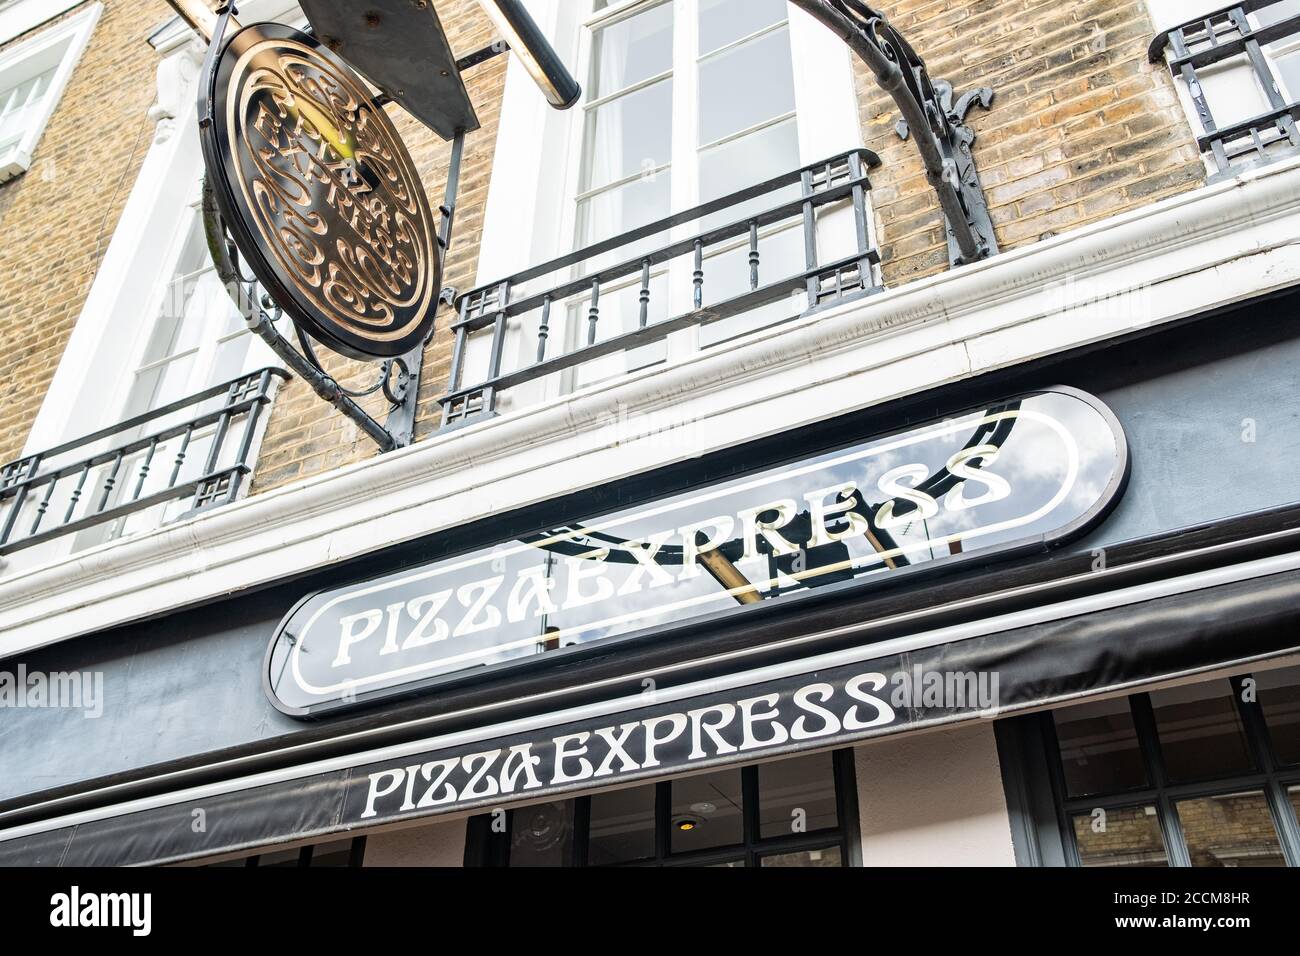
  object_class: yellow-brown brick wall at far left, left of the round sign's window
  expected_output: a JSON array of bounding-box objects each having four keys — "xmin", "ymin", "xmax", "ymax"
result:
[{"xmin": 0, "ymin": 0, "xmax": 169, "ymax": 463}]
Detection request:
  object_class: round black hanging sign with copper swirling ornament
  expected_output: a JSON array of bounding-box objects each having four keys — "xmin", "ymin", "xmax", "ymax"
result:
[{"xmin": 200, "ymin": 23, "xmax": 442, "ymax": 360}]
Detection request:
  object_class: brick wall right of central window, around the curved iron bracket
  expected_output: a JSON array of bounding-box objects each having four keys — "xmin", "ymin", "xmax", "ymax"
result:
[{"xmin": 858, "ymin": 0, "xmax": 1205, "ymax": 286}]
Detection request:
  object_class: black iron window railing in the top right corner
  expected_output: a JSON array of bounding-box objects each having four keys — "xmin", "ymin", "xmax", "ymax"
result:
[{"xmin": 1148, "ymin": 0, "xmax": 1300, "ymax": 176}]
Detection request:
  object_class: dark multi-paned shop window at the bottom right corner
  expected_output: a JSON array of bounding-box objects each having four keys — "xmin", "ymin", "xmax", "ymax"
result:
[{"xmin": 1049, "ymin": 667, "xmax": 1300, "ymax": 868}]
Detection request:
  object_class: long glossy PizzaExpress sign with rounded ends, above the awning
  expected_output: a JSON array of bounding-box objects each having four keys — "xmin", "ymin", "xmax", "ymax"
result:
[{"xmin": 267, "ymin": 389, "xmax": 1128, "ymax": 717}]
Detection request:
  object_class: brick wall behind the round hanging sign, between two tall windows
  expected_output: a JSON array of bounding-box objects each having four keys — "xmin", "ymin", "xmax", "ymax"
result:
[{"xmin": 245, "ymin": 0, "xmax": 506, "ymax": 494}]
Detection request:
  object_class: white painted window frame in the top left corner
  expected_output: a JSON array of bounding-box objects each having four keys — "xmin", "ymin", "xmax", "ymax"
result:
[{"xmin": 0, "ymin": 3, "xmax": 104, "ymax": 183}]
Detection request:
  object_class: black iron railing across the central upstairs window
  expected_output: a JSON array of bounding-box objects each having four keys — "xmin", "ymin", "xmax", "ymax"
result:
[{"xmin": 441, "ymin": 150, "xmax": 880, "ymax": 427}]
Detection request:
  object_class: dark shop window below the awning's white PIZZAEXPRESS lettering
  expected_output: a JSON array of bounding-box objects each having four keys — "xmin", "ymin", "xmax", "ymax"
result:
[{"xmin": 465, "ymin": 750, "xmax": 857, "ymax": 868}]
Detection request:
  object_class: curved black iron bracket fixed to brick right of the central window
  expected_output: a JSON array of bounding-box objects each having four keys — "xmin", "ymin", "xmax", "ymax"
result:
[{"xmin": 790, "ymin": 0, "xmax": 997, "ymax": 265}]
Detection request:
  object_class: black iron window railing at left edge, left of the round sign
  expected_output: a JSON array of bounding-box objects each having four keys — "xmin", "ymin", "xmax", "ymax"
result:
[{"xmin": 0, "ymin": 368, "xmax": 287, "ymax": 554}]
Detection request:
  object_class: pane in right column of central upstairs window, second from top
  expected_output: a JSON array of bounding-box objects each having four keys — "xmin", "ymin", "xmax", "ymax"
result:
[{"xmin": 699, "ymin": 29, "xmax": 794, "ymax": 144}]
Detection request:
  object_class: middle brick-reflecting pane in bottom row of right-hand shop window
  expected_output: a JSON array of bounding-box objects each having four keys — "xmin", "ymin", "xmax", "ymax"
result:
[{"xmin": 1178, "ymin": 792, "xmax": 1286, "ymax": 866}]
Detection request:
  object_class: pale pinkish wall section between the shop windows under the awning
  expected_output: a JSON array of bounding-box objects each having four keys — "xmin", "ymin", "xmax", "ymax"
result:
[{"xmin": 854, "ymin": 721, "xmax": 1015, "ymax": 866}]
